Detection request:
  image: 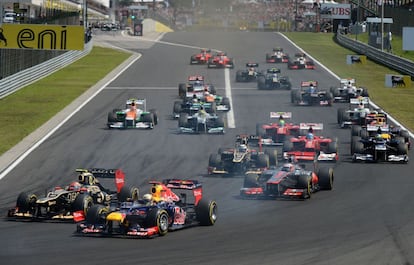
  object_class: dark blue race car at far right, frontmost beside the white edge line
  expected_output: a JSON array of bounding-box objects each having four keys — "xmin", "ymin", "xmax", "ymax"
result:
[{"xmin": 351, "ymin": 126, "xmax": 409, "ymax": 163}]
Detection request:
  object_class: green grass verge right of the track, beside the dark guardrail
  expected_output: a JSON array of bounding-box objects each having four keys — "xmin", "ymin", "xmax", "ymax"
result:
[{"xmin": 284, "ymin": 32, "xmax": 414, "ymax": 131}]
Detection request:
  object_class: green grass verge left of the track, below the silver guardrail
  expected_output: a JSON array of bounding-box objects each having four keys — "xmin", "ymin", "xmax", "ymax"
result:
[{"xmin": 0, "ymin": 46, "xmax": 131, "ymax": 155}]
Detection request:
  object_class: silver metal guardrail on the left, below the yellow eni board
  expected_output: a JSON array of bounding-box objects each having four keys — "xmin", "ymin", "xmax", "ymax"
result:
[{"xmin": 0, "ymin": 41, "xmax": 93, "ymax": 99}]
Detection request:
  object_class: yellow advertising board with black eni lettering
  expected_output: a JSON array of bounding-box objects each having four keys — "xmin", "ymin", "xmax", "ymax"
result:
[{"xmin": 0, "ymin": 24, "xmax": 85, "ymax": 50}]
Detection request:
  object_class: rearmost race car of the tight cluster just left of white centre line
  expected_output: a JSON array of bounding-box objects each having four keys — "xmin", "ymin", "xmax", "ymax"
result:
[{"xmin": 178, "ymin": 75, "xmax": 216, "ymax": 99}]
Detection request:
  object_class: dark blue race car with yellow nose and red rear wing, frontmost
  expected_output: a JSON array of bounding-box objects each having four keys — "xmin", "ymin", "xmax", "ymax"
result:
[{"xmin": 76, "ymin": 179, "xmax": 217, "ymax": 238}]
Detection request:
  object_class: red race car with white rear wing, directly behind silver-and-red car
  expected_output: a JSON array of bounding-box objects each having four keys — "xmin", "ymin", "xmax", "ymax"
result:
[{"xmin": 282, "ymin": 123, "xmax": 339, "ymax": 162}]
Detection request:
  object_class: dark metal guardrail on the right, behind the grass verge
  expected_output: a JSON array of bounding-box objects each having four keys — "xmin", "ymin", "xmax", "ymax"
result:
[{"xmin": 336, "ymin": 33, "xmax": 414, "ymax": 77}]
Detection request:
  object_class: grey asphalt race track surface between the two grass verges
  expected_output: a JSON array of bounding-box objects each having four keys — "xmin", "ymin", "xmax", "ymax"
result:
[{"xmin": 0, "ymin": 32, "xmax": 414, "ymax": 265}]
